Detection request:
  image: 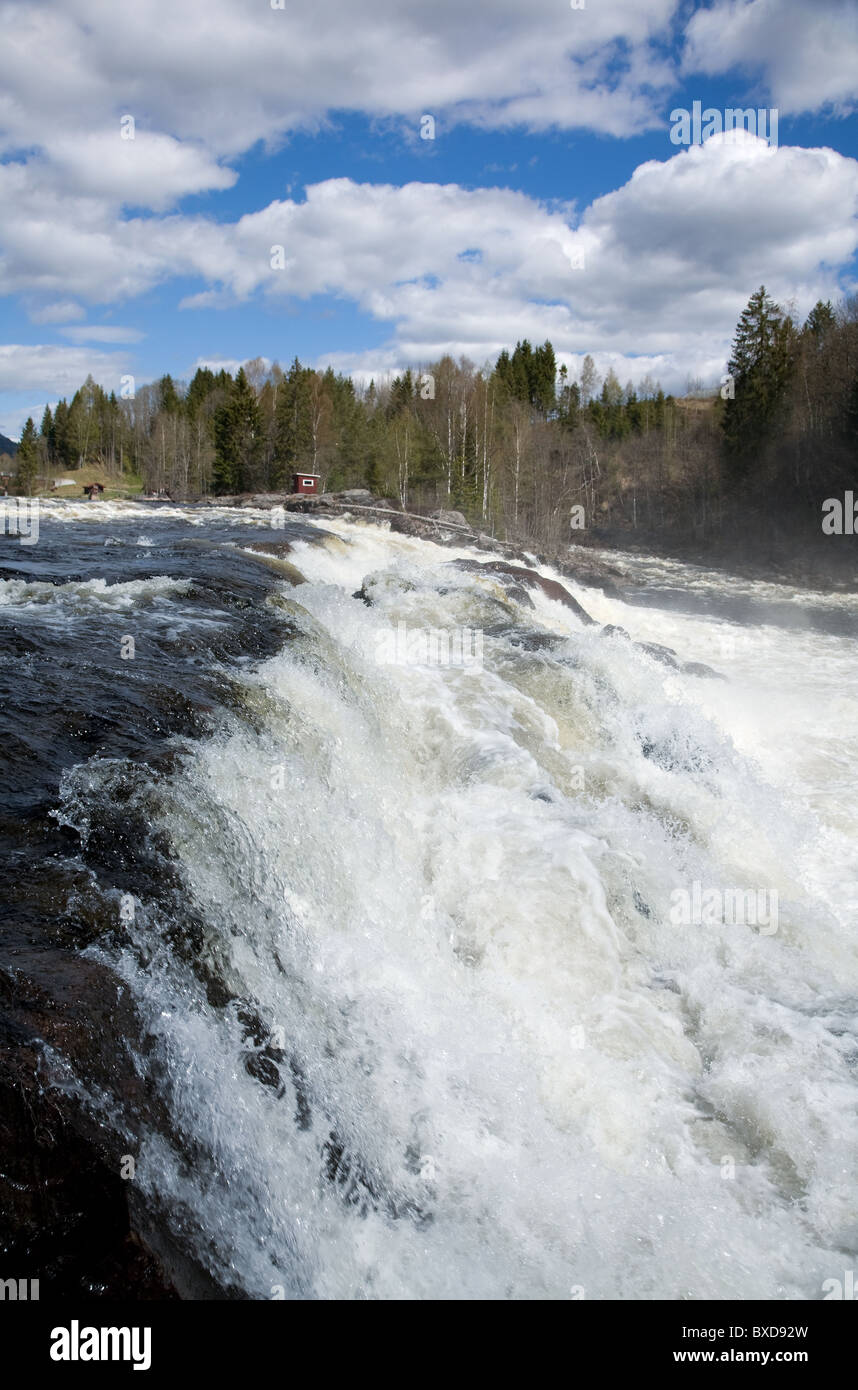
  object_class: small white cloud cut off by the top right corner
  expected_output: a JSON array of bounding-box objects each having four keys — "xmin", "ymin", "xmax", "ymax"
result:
[{"xmin": 684, "ymin": 0, "xmax": 858, "ymax": 115}]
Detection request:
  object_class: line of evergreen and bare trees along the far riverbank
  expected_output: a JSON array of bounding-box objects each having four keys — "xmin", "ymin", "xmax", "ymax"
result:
[{"xmin": 15, "ymin": 288, "xmax": 858, "ymax": 546}]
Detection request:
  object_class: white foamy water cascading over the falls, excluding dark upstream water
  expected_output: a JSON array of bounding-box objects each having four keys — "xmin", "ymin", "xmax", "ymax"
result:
[{"xmin": 70, "ymin": 507, "xmax": 858, "ymax": 1300}]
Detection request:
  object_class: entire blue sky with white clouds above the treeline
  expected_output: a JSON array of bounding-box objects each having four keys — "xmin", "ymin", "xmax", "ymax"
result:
[{"xmin": 0, "ymin": 0, "xmax": 858, "ymax": 438}]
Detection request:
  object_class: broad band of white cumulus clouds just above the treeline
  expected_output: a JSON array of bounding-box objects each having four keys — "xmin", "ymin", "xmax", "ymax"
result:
[{"xmin": 0, "ymin": 135, "xmax": 858, "ymax": 400}]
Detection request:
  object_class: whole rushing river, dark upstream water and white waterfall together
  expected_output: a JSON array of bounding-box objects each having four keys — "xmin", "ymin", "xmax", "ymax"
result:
[{"xmin": 0, "ymin": 503, "xmax": 858, "ymax": 1298}]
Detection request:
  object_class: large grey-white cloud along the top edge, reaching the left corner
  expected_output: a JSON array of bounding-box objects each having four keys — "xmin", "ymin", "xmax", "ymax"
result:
[{"xmin": 0, "ymin": 0, "xmax": 679, "ymax": 196}]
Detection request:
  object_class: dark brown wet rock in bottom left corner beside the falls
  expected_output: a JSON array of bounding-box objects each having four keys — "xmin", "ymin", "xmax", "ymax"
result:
[{"xmin": 0, "ymin": 942, "xmax": 177, "ymax": 1300}]
